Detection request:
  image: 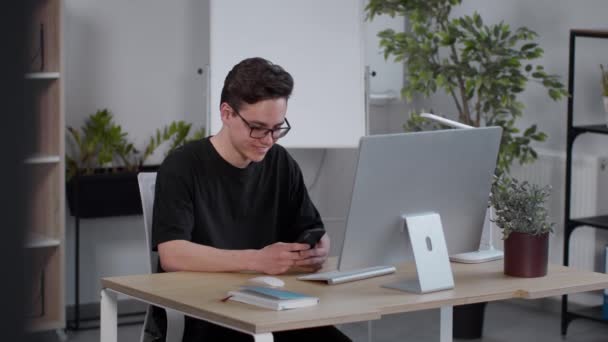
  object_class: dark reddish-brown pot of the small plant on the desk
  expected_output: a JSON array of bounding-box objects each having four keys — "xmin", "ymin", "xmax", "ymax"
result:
[{"xmin": 504, "ymin": 232, "xmax": 549, "ymax": 278}]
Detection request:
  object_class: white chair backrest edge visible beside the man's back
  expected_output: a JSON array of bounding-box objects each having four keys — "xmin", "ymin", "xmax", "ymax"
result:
[{"xmin": 137, "ymin": 172, "xmax": 158, "ymax": 273}]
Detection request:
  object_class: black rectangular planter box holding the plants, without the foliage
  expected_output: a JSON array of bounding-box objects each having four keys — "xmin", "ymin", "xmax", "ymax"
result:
[{"xmin": 66, "ymin": 166, "xmax": 158, "ymax": 218}]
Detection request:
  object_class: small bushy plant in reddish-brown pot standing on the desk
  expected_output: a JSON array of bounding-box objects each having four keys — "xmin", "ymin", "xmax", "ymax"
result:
[{"xmin": 490, "ymin": 175, "xmax": 555, "ymax": 278}]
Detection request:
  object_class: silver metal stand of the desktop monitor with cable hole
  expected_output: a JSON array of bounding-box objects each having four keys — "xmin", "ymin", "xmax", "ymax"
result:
[{"xmin": 382, "ymin": 213, "xmax": 454, "ymax": 293}]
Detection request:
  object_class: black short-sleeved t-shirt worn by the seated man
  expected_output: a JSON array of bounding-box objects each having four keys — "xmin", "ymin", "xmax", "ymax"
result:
[{"xmin": 152, "ymin": 138, "xmax": 323, "ymax": 341}]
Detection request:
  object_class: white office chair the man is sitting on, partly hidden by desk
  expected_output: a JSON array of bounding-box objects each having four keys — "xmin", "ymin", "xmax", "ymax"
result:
[{"xmin": 137, "ymin": 172, "xmax": 184, "ymax": 342}]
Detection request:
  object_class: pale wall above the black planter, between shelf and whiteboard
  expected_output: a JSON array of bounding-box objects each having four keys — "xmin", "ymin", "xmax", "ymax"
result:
[{"xmin": 64, "ymin": 0, "xmax": 209, "ymax": 164}]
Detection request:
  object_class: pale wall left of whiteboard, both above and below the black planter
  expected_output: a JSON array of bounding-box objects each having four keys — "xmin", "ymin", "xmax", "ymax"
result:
[{"xmin": 64, "ymin": 0, "xmax": 209, "ymax": 304}]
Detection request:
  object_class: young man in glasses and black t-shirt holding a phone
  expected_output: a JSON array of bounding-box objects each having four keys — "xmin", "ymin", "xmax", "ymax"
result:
[{"xmin": 152, "ymin": 58, "xmax": 349, "ymax": 342}]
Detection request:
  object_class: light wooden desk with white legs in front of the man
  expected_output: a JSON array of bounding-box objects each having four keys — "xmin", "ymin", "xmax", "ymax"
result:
[{"xmin": 101, "ymin": 260, "xmax": 608, "ymax": 342}]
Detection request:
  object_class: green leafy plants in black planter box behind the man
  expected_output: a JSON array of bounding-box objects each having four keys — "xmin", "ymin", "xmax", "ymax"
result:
[{"xmin": 66, "ymin": 109, "xmax": 204, "ymax": 218}]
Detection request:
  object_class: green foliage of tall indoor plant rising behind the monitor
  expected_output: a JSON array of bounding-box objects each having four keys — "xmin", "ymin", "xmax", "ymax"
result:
[{"xmin": 366, "ymin": 0, "xmax": 567, "ymax": 173}]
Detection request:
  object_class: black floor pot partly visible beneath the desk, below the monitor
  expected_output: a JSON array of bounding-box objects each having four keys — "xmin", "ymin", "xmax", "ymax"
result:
[{"xmin": 452, "ymin": 302, "xmax": 488, "ymax": 340}]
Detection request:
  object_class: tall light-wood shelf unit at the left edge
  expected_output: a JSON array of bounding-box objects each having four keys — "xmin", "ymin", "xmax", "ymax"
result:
[{"xmin": 24, "ymin": 0, "xmax": 65, "ymax": 331}]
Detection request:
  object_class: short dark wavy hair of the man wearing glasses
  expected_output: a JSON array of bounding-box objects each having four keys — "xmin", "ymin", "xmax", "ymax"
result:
[{"xmin": 220, "ymin": 57, "xmax": 293, "ymax": 111}]
